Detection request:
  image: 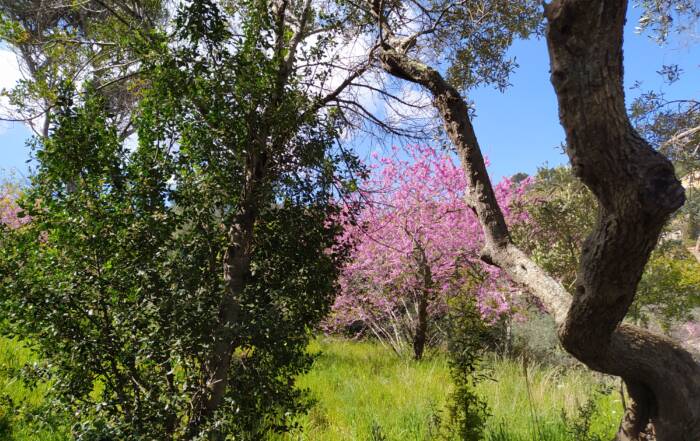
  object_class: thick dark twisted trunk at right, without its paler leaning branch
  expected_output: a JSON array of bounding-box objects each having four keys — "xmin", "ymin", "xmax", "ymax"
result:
[{"xmin": 546, "ymin": 0, "xmax": 700, "ymax": 441}]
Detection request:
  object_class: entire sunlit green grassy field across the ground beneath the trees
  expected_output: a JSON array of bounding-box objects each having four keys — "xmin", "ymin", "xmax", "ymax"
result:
[{"xmin": 0, "ymin": 338, "xmax": 622, "ymax": 441}]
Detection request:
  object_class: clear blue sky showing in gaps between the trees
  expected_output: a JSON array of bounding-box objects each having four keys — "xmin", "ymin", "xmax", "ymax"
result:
[{"xmin": 0, "ymin": 8, "xmax": 700, "ymax": 180}]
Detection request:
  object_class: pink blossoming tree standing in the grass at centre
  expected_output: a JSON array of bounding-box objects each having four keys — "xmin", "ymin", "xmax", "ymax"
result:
[{"xmin": 327, "ymin": 146, "xmax": 520, "ymax": 359}]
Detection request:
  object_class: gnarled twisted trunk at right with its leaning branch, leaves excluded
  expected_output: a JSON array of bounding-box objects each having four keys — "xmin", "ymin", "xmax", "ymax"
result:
[{"xmin": 379, "ymin": 0, "xmax": 700, "ymax": 441}]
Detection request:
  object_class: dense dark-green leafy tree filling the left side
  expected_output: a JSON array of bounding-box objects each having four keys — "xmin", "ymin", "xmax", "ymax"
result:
[{"xmin": 0, "ymin": 2, "xmax": 354, "ymax": 440}]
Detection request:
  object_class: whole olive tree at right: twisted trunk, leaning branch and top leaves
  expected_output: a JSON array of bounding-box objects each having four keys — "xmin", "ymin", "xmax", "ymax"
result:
[{"xmin": 340, "ymin": 0, "xmax": 700, "ymax": 441}]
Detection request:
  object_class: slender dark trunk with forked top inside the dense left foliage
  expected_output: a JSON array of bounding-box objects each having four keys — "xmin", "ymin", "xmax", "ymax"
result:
[{"xmin": 180, "ymin": 0, "xmax": 322, "ymax": 426}]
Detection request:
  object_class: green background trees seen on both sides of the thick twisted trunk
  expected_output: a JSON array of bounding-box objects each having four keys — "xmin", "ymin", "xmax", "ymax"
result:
[{"xmin": 511, "ymin": 167, "xmax": 700, "ymax": 338}]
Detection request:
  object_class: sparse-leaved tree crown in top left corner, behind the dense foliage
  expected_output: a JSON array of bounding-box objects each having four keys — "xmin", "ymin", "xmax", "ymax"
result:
[{"xmin": 0, "ymin": 0, "xmax": 165, "ymax": 138}]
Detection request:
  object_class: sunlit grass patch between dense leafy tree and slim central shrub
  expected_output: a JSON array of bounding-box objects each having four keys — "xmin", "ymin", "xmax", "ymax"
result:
[{"xmin": 292, "ymin": 339, "xmax": 450, "ymax": 441}]
